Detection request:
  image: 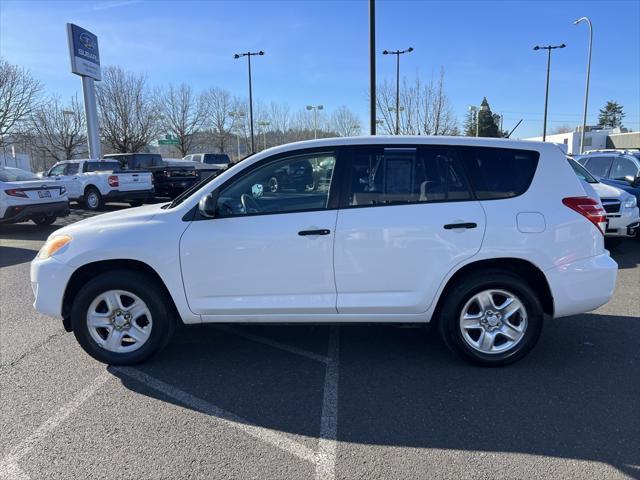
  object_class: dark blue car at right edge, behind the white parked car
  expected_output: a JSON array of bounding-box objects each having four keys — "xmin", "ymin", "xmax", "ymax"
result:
[{"xmin": 574, "ymin": 150, "xmax": 640, "ymax": 204}]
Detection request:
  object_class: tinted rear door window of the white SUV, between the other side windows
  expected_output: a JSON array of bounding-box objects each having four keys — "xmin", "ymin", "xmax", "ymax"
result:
[{"xmin": 346, "ymin": 147, "xmax": 471, "ymax": 207}]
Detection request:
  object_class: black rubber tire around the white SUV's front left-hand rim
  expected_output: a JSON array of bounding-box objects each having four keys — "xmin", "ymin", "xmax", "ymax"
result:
[{"xmin": 71, "ymin": 270, "xmax": 176, "ymax": 365}]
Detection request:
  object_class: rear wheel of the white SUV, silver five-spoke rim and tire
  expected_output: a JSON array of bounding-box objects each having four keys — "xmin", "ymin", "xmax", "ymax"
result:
[{"xmin": 437, "ymin": 271, "xmax": 544, "ymax": 366}]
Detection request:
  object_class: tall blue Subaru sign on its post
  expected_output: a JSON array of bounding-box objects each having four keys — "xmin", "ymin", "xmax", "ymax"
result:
[{"xmin": 67, "ymin": 23, "xmax": 102, "ymax": 160}]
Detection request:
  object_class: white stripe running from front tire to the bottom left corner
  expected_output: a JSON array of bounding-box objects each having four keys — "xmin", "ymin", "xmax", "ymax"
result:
[{"xmin": 0, "ymin": 371, "xmax": 113, "ymax": 479}]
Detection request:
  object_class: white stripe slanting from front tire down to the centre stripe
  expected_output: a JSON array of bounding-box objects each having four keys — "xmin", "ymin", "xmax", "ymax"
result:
[{"xmin": 114, "ymin": 367, "xmax": 316, "ymax": 463}]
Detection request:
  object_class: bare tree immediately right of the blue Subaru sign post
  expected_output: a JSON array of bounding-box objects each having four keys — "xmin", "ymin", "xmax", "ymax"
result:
[{"xmin": 96, "ymin": 67, "xmax": 161, "ymax": 153}]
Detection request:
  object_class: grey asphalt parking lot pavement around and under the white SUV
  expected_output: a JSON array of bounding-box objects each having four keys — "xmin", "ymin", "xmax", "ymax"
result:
[{"xmin": 0, "ymin": 206, "xmax": 640, "ymax": 480}]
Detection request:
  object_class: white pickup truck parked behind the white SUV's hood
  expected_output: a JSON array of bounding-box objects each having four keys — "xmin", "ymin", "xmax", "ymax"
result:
[{"xmin": 42, "ymin": 160, "xmax": 154, "ymax": 210}]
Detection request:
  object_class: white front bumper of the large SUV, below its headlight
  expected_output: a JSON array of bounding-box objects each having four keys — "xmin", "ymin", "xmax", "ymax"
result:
[{"xmin": 30, "ymin": 257, "xmax": 74, "ymax": 318}]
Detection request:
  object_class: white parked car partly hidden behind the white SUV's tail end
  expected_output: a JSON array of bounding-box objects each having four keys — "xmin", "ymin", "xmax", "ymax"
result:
[{"xmin": 569, "ymin": 159, "xmax": 640, "ymax": 247}]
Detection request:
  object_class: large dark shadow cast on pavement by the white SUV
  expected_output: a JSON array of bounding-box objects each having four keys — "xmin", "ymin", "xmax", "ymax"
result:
[{"xmin": 109, "ymin": 314, "xmax": 640, "ymax": 477}]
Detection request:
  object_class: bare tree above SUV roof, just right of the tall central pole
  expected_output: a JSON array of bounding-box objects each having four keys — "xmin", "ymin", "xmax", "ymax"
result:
[{"xmin": 376, "ymin": 70, "xmax": 458, "ymax": 135}]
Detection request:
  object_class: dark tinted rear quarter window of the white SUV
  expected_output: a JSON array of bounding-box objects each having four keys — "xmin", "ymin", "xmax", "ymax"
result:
[{"xmin": 461, "ymin": 147, "xmax": 540, "ymax": 200}]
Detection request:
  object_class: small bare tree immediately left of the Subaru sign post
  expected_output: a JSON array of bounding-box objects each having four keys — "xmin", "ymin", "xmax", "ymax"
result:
[{"xmin": 30, "ymin": 96, "xmax": 87, "ymax": 161}]
